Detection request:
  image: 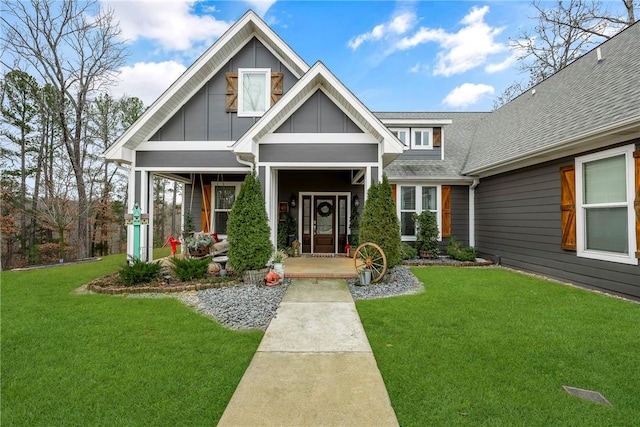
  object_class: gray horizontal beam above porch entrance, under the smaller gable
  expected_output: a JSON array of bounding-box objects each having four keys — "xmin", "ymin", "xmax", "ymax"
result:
[{"xmin": 259, "ymin": 145, "xmax": 378, "ymax": 163}]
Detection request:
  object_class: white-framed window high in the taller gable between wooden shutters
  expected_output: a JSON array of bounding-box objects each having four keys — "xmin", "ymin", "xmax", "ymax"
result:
[{"xmin": 238, "ymin": 68, "xmax": 271, "ymax": 117}]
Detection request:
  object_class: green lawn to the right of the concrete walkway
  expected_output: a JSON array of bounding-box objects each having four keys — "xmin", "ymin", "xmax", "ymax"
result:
[{"xmin": 357, "ymin": 267, "xmax": 640, "ymax": 427}]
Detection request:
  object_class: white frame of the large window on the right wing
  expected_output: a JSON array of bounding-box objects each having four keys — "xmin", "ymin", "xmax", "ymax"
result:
[{"xmin": 575, "ymin": 144, "xmax": 638, "ymax": 265}]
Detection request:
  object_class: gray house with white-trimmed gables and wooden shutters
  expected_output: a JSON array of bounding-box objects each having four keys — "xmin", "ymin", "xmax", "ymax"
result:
[{"xmin": 105, "ymin": 11, "xmax": 640, "ymax": 298}]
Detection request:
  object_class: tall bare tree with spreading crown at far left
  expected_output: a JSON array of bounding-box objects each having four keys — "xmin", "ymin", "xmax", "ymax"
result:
[{"xmin": 0, "ymin": 0, "xmax": 126, "ymax": 257}]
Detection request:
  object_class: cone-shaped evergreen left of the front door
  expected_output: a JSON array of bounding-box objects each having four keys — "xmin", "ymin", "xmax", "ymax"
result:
[{"xmin": 227, "ymin": 171, "xmax": 273, "ymax": 273}]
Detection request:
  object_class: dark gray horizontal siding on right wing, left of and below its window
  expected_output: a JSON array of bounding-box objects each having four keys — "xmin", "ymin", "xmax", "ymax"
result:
[{"xmin": 475, "ymin": 158, "xmax": 640, "ymax": 299}]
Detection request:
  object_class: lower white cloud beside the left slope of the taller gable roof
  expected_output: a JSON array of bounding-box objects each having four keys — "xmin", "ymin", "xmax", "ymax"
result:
[{"xmin": 111, "ymin": 61, "xmax": 186, "ymax": 107}]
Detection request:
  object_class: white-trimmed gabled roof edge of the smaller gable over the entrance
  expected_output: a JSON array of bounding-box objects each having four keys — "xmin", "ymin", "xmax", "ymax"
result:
[{"xmin": 233, "ymin": 61, "xmax": 404, "ymax": 165}]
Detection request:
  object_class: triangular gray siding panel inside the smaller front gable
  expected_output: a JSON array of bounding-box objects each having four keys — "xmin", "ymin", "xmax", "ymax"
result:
[{"xmin": 276, "ymin": 90, "xmax": 362, "ymax": 133}]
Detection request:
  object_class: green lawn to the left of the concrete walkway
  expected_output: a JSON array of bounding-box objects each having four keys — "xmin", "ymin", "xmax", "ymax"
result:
[{"xmin": 1, "ymin": 253, "xmax": 262, "ymax": 426}]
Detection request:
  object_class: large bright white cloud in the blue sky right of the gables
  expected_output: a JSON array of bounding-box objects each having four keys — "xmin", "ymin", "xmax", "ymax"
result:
[{"xmin": 396, "ymin": 6, "xmax": 509, "ymax": 77}]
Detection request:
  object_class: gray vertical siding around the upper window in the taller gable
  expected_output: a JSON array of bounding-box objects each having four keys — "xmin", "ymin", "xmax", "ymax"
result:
[{"xmin": 150, "ymin": 38, "xmax": 297, "ymax": 141}]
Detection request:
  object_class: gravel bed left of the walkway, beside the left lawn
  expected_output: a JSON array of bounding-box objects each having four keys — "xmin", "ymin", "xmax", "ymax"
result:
[{"xmin": 175, "ymin": 281, "xmax": 287, "ymax": 331}]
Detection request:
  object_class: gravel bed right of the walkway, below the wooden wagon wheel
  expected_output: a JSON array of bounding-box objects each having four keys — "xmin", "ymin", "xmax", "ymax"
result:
[{"xmin": 347, "ymin": 265, "xmax": 424, "ymax": 300}]
